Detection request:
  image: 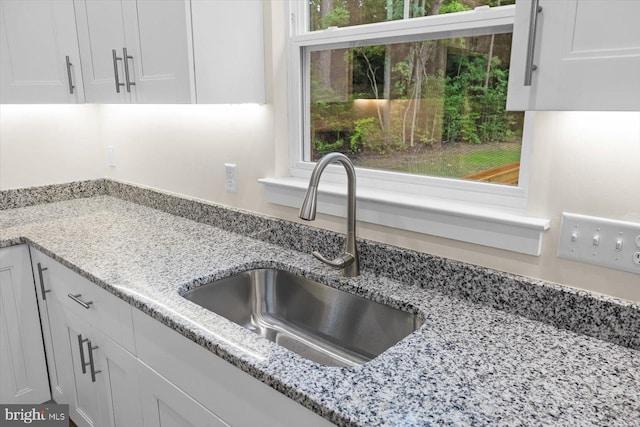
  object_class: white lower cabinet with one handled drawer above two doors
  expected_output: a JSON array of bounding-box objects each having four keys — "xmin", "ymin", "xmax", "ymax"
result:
[{"xmin": 31, "ymin": 250, "xmax": 142, "ymax": 427}]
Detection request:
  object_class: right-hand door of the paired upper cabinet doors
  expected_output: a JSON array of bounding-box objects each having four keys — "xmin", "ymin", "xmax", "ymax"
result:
[{"xmin": 121, "ymin": 0, "xmax": 193, "ymax": 104}]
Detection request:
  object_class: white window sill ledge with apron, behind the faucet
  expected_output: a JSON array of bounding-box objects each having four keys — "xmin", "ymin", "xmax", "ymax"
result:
[{"xmin": 259, "ymin": 177, "xmax": 550, "ymax": 256}]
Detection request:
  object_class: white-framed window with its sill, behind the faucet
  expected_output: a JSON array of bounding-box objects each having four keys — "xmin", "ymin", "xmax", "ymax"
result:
[{"xmin": 263, "ymin": 0, "xmax": 549, "ymax": 254}]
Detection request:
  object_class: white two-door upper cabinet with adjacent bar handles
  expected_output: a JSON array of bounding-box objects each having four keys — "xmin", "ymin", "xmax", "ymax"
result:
[{"xmin": 75, "ymin": 0, "xmax": 193, "ymax": 104}]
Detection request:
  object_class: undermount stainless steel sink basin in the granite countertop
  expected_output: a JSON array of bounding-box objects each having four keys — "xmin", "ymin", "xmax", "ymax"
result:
[{"xmin": 182, "ymin": 269, "xmax": 422, "ymax": 367}]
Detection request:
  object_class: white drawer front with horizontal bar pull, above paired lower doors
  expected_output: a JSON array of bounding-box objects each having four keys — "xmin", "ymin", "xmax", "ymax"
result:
[{"xmin": 32, "ymin": 250, "xmax": 135, "ymax": 354}]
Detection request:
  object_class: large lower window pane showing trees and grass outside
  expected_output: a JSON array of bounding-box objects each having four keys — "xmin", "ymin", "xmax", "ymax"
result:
[{"xmin": 306, "ymin": 31, "xmax": 524, "ymax": 185}]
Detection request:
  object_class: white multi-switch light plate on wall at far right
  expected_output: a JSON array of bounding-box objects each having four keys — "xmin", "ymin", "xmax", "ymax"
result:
[{"xmin": 558, "ymin": 212, "xmax": 640, "ymax": 274}]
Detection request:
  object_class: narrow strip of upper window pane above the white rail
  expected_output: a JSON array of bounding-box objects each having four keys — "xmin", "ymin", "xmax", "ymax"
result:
[{"xmin": 309, "ymin": 0, "xmax": 515, "ymax": 31}]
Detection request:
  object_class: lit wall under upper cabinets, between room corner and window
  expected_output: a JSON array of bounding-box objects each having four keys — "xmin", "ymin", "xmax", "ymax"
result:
[{"xmin": 100, "ymin": 104, "xmax": 274, "ymax": 211}]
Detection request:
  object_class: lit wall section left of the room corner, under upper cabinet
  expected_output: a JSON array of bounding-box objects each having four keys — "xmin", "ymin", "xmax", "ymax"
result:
[{"xmin": 0, "ymin": 105, "xmax": 105, "ymax": 190}]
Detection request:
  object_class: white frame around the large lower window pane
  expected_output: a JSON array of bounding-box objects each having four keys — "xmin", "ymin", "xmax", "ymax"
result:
[{"xmin": 289, "ymin": 1, "xmax": 533, "ymax": 213}]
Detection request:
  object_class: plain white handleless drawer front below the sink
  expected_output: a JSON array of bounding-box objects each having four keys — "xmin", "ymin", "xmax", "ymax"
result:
[{"xmin": 133, "ymin": 309, "xmax": 333, "ymax": 427}]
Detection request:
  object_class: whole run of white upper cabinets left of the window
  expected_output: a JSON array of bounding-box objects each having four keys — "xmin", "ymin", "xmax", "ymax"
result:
[{"xmin": 0, "ymin": 0, "xmax": 265, "ymax": 104}]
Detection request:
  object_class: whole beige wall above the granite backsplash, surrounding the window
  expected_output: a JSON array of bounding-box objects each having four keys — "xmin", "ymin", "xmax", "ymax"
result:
[{"xmin": 0, "ymin": 2, "xmax": 640, "ymax": 301}]
